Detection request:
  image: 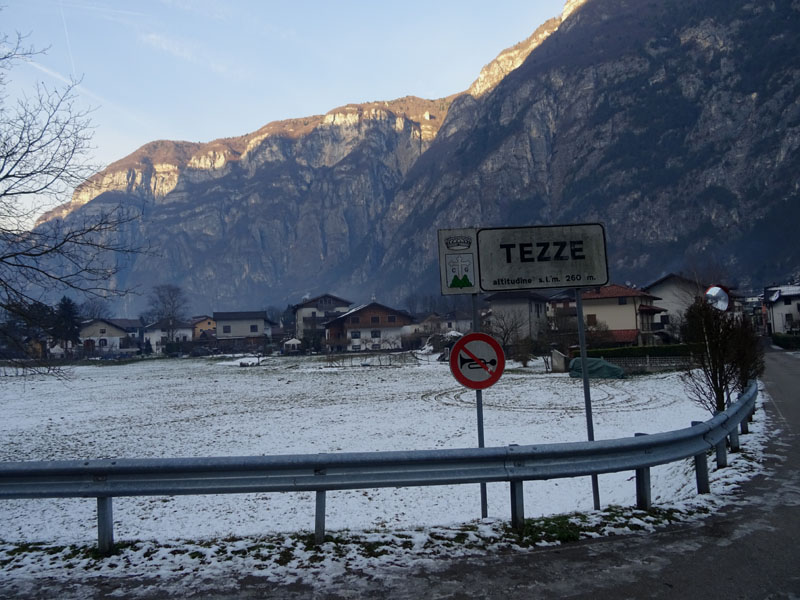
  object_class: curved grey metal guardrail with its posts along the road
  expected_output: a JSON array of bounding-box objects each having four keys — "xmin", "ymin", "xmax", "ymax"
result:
[{"xmin": 0, "ymin": 383, "xmax": 758, "ymax": 553}]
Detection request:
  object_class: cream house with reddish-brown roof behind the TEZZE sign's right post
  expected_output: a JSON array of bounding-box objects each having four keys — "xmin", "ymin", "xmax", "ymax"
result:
[{"xmin": 549, "ymin": 283, "xmax": 665, "ymax": 346}]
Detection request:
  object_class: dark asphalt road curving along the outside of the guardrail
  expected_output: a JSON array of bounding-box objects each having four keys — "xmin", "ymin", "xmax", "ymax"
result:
[{"xmin": 6, "ymin": 350, "xmax": 800, "ymax": 600}]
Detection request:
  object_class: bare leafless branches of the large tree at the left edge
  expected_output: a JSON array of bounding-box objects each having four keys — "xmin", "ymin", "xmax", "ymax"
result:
[{"xmin": 0, "ymin": 28, "xmax": 137, "ymax": 364}]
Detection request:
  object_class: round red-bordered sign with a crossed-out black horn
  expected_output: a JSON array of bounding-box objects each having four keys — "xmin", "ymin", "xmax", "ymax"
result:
[{"xmin": 450, "ymin": 333, "xmax": 506, "ymax": 390}]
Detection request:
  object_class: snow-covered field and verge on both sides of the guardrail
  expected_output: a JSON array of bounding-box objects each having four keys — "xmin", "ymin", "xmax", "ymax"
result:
[{"xmin": 0, "ymin": 357, "xmax": 766, "ymax": 583}]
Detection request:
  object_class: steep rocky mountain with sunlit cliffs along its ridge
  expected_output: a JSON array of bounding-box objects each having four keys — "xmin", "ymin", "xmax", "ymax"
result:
[{"xmin": 43, "ymin": 0, "xmax": 800, "ymax": 314}]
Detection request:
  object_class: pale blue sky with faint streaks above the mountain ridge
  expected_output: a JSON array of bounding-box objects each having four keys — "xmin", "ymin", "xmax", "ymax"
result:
[{"xmin": 6, "ymin": 0, "xmax": 563, "ymax": 171}]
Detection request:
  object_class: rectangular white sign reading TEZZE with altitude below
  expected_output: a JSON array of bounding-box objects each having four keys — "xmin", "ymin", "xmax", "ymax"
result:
[{"xmin": 478, "ymin": 223, "xmax": 608, "ymax": 292}]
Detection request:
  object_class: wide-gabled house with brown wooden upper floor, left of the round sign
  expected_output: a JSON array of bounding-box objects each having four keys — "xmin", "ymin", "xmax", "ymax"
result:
[{"xmin": 325, "ymin": 302, "xmax": 412, "ymax": 352}]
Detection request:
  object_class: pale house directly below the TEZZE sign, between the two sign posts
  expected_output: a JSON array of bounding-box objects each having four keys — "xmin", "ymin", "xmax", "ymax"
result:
[{"xmin": 484, "ymin": 290, "xmax": 548, "ymax": 344}]
